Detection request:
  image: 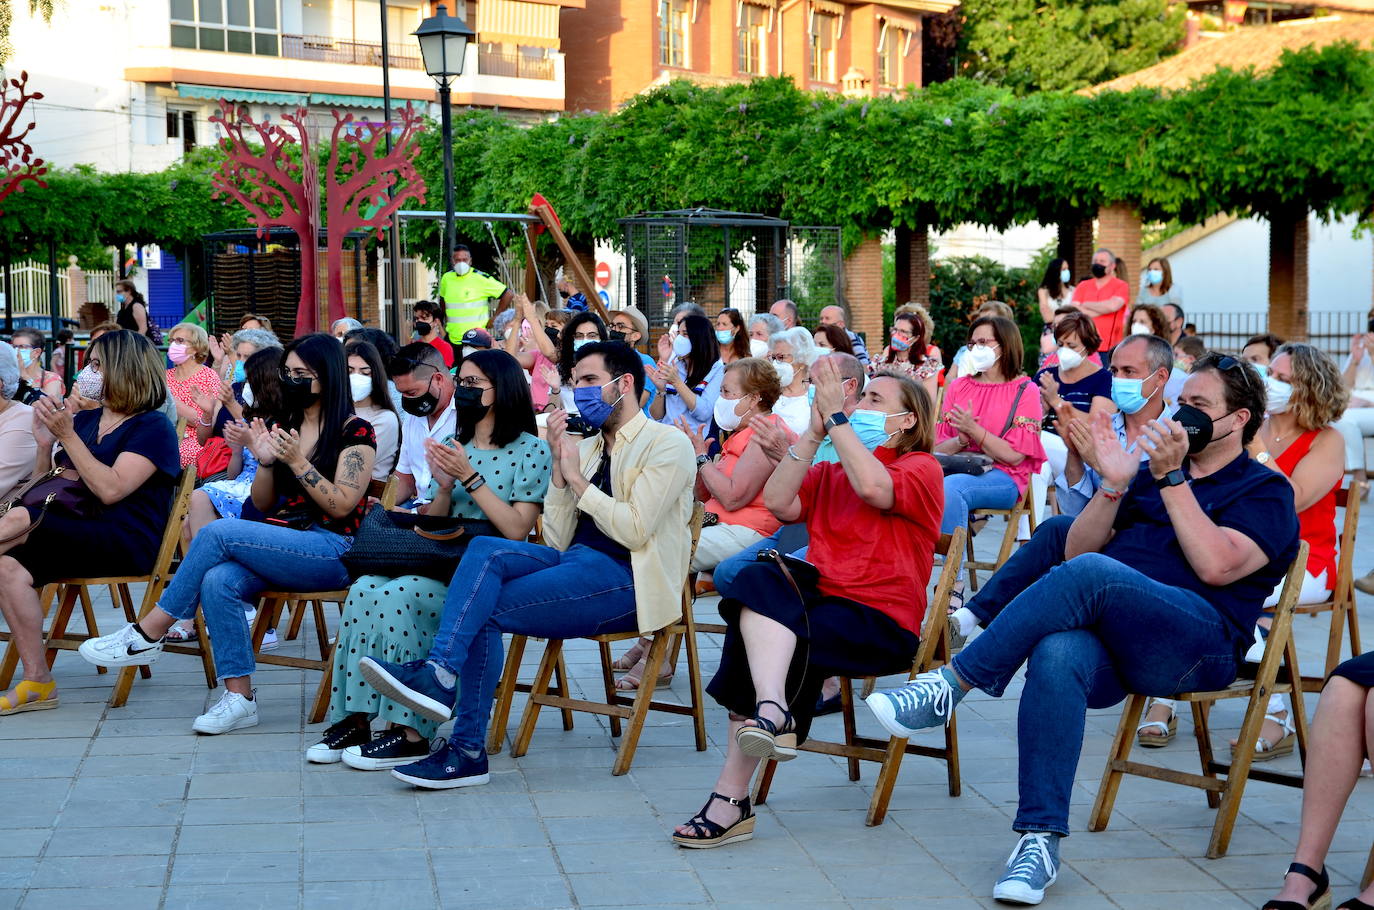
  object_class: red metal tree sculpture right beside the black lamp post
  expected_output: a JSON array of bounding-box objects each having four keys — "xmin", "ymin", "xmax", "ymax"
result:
[{"xmin": 324, "ymin": 104, "xmax": 425, "ymax": 323}]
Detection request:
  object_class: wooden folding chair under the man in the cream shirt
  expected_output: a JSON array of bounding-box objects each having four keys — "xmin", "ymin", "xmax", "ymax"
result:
[{"xmin": 511, "ymin": 503, "xmax": 706, "ymax": 775}]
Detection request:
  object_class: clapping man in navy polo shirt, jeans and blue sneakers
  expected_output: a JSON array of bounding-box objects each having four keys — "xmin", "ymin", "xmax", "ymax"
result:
[{"xmin": 868, "ymin": 355, "xmax": 1298, "ymax": 905}]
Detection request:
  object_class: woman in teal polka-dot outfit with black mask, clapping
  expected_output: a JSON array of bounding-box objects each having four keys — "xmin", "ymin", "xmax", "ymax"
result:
[{"xmin": 305, "ymin": 351, "xmax": 551, "ymax": 771}]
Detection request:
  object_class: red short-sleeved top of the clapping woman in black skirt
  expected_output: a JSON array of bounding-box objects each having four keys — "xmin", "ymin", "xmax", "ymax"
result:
[{"xmin": 798, "ymin": 445, "xmax": 944, "ymax": 635}]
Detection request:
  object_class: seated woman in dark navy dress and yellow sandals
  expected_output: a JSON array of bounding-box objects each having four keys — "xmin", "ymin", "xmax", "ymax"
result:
[{"xmin": 0, "ymin": 331, "xmax": 181, "ymax": 715}]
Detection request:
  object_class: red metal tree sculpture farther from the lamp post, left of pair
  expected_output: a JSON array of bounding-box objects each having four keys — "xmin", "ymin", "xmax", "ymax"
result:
[{"xmin": 210, "ymin": 100, "xmax": 320, "ymax": 334}]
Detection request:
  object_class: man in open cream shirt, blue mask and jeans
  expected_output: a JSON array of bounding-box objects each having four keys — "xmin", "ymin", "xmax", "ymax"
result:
[{"xmin": 359, "ymin": 342, "xmax": 697, "ymax": 789}]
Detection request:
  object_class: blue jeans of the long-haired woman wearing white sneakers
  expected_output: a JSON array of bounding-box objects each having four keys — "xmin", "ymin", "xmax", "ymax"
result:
[{"xmin": 158, "ymin": 518, "xmax": 353, "ymax": 679}]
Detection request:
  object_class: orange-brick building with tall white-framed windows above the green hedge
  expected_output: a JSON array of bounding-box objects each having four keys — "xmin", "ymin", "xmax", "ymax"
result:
[{"xmin": 561, "ymin": 0, "xmax": 958, "ymax": 110}]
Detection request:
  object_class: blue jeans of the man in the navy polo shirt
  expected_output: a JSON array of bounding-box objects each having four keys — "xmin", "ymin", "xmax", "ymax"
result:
[{"xmin": 954, "ymin": 536, "xmax": 1238, "ymax": 834}]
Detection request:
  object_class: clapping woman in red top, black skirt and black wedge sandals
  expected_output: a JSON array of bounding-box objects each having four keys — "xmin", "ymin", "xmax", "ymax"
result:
[{"xmin": 673, "ymin": 357, "xmax": 944, "ymax": 848}]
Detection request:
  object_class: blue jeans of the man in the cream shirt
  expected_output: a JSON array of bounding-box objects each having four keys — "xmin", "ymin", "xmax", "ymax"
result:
[{"xmin": 430, "ymin": 537, "xmax": 638, "ymax": 751}]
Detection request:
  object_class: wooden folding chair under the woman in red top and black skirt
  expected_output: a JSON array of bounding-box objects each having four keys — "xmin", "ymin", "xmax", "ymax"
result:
[{"xmin": 753, "ymin": 528, "xmax": 966, "ymax": 826}]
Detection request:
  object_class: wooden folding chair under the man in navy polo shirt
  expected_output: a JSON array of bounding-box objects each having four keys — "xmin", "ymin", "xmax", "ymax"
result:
[{"xmin": 1088, "ymin": 543, "xmax": 1307, "ymax": 859}]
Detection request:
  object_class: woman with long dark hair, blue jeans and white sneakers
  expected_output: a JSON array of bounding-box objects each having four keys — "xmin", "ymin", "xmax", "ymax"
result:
[{"xmin": 81, "ymin": 333, "xmax": 376, "ymax": 734}]
